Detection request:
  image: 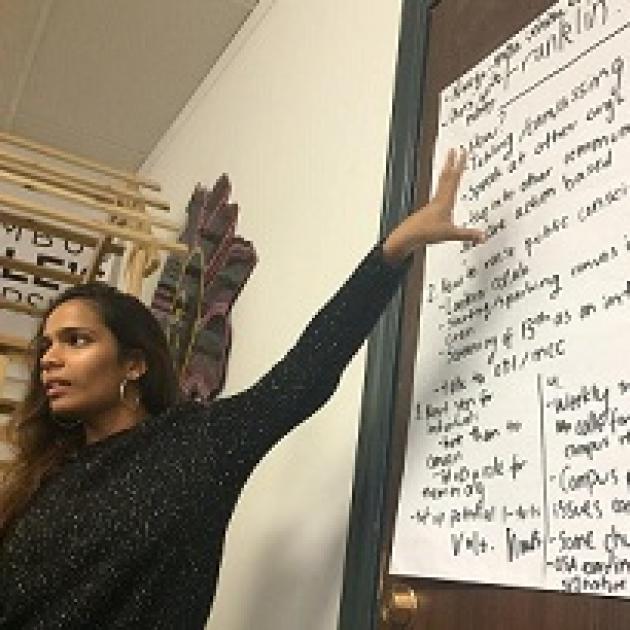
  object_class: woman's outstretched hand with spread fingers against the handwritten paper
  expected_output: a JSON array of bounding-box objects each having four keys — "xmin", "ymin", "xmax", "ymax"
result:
[{"xmin": 383, "ymin": 149, "xmax": 485, "ymax": 264}]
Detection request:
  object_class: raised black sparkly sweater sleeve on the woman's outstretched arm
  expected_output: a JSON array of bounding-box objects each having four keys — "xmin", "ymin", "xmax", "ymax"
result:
[{"xmin": 200, "ymin": 245, "xmax": 408, "ymax": 476}]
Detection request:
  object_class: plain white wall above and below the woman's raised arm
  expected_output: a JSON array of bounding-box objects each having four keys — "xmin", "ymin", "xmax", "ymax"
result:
[{"xmin": 143, "ymin": 0, "xmax": 400, "ymax": 630}]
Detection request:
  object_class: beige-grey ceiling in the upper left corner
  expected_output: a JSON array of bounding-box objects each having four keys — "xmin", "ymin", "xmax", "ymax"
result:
[{"xmin": 0, "ymin": 0, "xmax": 258, "ymax": 170}]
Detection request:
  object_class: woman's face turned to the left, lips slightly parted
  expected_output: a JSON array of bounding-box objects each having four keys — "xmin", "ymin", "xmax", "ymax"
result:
[{"xmin": 40, "ymin": 299, "xmax": 137, "ymax": 421}]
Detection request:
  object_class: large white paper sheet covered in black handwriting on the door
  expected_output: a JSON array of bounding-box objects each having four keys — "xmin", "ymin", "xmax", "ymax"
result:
[{"xmin": 390, "ymin": 0, "xmax": 630, "ymax": 597}]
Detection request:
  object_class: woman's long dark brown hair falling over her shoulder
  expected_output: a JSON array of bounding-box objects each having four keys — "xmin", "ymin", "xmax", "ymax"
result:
[{"xmin": 0, "ymin": 282, "xmax": 179, "ymax": 540}]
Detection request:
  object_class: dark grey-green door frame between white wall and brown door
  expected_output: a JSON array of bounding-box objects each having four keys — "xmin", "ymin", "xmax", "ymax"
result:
[{"xmin": 338, "ymin": 0, "xmax": 440, "ymax": 630}]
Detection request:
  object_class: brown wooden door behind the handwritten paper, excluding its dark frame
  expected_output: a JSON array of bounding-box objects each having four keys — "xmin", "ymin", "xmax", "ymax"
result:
[{"xmin": 381, "ymin": 0, "xmax": 630, "ymax": 630}]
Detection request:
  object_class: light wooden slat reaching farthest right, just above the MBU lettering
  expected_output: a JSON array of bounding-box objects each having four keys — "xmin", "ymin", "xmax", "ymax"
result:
[{"xmin": 0, "ymin": 195, "xmax": 188, "ymax": 255}]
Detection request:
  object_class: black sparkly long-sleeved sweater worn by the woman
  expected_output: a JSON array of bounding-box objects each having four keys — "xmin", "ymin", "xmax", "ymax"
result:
[{"xmin": 0, "ymin": 246, "xmax": 407, "ymax": 630}]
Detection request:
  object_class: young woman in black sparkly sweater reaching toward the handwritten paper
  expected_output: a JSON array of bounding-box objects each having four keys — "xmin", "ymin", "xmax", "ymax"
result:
[{"xmin": 0, "ymin": 151, "xmax": 482, "ymax": 630}]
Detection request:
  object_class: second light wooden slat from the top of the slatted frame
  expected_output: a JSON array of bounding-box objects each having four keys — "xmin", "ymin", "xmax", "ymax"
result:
[{"xmin": 0, "ymin": 151, "xmax": 170, "ymax": 212}]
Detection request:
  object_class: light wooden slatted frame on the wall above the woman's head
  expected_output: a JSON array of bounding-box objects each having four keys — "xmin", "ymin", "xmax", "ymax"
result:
[{"xmin": 0, "ymin": 132, "xmax": 188, "ymax": 414}]
